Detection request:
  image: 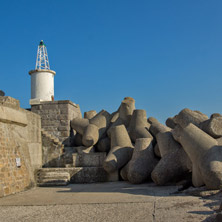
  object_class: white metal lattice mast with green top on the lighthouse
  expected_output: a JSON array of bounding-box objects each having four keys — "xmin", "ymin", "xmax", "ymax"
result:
[{"xmin": 35, "ymin": 40, "xmax": 50, "ymax": 70}]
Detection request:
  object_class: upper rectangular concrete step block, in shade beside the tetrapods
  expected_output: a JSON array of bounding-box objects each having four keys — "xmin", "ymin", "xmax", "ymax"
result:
[{"xmin": 72, "ymin": 152, "xmax": 106, "ymax": 167}]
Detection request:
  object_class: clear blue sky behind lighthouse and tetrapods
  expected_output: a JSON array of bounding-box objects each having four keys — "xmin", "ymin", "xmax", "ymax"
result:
[{"xmin": 0, "ymin": 0, "xmax": 222, "ymax": 122}]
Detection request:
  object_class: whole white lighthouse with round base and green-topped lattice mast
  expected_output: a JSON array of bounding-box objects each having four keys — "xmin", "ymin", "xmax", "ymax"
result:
[{"xmin": 29, "ymin": 40, "xmax": 56, "ymax": 105}]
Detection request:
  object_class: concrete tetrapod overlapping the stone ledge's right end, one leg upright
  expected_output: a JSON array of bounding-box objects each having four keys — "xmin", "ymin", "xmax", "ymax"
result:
[{"xmin": 103, "ymin": 125, "xmax": 134, "ymax": 173}]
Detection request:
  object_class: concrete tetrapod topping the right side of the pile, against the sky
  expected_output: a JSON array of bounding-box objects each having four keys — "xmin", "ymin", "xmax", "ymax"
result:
[{"xmin": 173, "ymin": 108, "xmax": 208, "ymax": 127}]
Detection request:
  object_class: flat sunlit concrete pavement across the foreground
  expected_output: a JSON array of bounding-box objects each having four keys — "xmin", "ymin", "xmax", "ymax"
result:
[{"xmin": 0, "ymin": 182, "xmax": 219, "ymax": 222}]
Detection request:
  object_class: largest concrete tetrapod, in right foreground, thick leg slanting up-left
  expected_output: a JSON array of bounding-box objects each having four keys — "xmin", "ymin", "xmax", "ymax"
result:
[{"xmin": 173, "ymin": 123, "xmax": 222, "ymax": 189}]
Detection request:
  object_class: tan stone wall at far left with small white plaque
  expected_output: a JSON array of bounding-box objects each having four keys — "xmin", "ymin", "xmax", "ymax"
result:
[{"xmin": 0, "ymin": 97, "xmax": 42, "ymax": 197}]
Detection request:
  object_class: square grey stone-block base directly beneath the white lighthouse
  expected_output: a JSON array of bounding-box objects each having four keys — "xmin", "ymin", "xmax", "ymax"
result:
[{"xmin": 31, "ymin": 100, "xmax": 82, "ymax": 146}]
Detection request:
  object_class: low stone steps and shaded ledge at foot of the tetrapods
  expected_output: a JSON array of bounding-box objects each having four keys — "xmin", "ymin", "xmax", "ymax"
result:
[{"xmin": 36, "ymin": 147, "xmax": 119, "ymax": 186}]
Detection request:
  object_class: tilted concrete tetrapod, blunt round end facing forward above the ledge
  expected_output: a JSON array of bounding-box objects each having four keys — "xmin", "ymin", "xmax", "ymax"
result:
[{"xmin": 82, "ymin": 110, "xmax": 112, "ymax": 147}]
